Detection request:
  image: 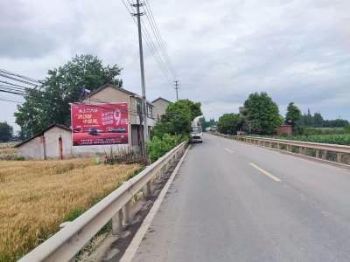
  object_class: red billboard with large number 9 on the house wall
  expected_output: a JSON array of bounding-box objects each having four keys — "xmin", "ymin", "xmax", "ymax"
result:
[{"xmin": 71, "ymin": 103, "xmax": 129, "ymax": 146}]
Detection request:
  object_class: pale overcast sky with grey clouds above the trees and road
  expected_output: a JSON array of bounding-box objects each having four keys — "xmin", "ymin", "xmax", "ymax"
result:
[{"xmin": 0, "ymin": 0, "xmax": 350, "ymax": 131}]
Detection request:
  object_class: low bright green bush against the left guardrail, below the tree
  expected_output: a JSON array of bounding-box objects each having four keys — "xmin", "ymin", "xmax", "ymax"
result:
[{"xmin": 147, "ymin": 134, "xmax": 185, "ymax": 162}]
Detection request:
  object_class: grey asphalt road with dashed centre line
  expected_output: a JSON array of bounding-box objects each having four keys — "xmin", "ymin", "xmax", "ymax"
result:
[{"xmin": 134, "ymin": 135, "xmax": 350, "ymax": 262}]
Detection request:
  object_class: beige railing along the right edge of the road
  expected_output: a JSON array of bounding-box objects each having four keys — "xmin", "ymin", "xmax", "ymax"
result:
[{"xmin": 234, "ymin": 136, "xmax": 350, "ymax": 165}]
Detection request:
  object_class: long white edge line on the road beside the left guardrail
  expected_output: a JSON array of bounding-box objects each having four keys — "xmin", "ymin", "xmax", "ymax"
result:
[{"xmin": 120, "ymin": 146, "xmax": 191, "ymax": 262}]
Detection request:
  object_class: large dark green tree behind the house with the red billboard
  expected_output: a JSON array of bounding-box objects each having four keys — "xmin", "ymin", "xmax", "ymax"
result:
[{"xmin": 15, "ymin": 55, "xmax": 122, "ymax": 137}]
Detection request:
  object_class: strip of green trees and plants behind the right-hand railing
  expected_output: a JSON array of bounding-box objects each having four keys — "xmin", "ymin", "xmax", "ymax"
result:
[{"xmin": 217, "ymin": 93, "xmax": 350, "ymax": 145}]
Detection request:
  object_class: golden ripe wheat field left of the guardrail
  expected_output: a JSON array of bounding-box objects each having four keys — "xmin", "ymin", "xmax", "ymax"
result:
[{"xmin": 0, "ymin": 159, "xmax": 141, "ymax": 261}]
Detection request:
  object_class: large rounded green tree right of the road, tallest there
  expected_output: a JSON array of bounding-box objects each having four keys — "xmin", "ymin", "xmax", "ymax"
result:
[{"xmin": 243, "ymin": 92, "xmax": 282, "ymax": 135}]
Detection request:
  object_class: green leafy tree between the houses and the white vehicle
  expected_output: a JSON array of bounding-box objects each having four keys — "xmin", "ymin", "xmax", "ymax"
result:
[{"xmin": 152, "ymin": 99, "xmax": 202, "ymax": 137}]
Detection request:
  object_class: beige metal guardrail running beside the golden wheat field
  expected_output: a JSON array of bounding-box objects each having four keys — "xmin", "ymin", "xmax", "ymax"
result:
[{"xmin": 19, "ymin": 142, "xmax": 186, "ymax": 262}]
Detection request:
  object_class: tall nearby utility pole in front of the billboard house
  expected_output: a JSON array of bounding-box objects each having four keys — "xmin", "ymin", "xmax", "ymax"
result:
[{"xmin": 133, "ymin": 0, "xmax": 148, "ymax": 156}]
